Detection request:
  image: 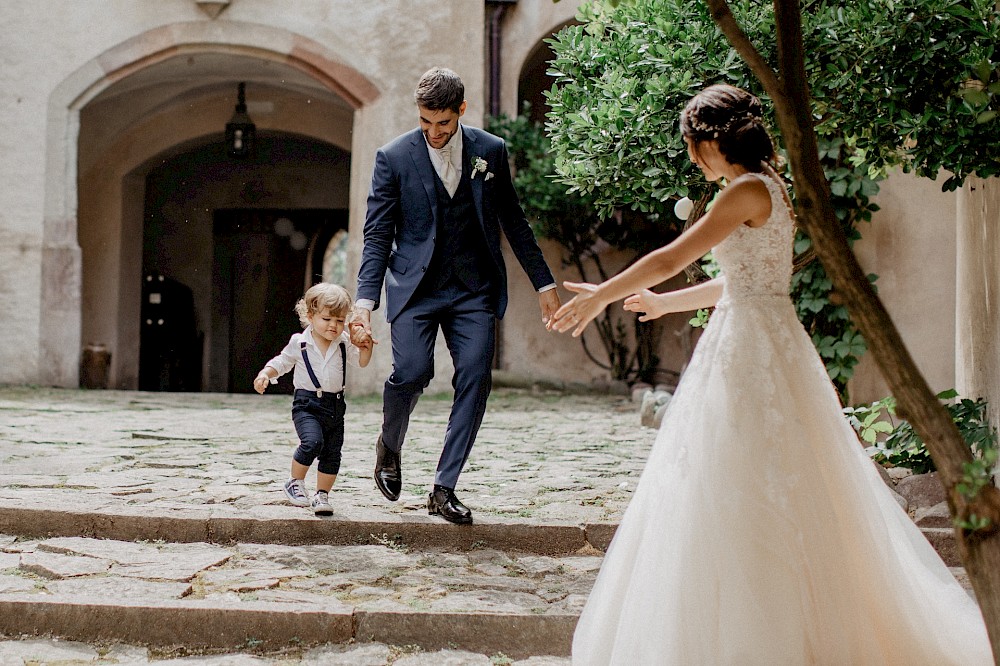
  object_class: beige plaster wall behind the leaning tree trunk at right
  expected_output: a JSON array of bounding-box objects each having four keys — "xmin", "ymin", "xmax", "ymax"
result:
[{"xmin": 850, "ymin": 172, "xmax": 957, "ymax": 404}]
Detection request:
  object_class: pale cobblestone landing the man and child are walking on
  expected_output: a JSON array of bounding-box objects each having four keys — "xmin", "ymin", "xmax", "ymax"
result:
[{"xmin": 0, "ymin": 388, "xmax": 653, "ymax": 524}]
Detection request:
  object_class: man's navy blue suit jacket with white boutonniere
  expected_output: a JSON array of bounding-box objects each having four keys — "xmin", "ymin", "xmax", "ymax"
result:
[{"xmin": 358, "ymin": 125, "xmax": 555, "ymax": 323}]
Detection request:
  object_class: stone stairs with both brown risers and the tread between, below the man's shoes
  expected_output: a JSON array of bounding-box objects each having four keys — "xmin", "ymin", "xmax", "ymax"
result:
[{"xmin": 0, "ymin": 507, "xmax": 610, "ymax": 659}]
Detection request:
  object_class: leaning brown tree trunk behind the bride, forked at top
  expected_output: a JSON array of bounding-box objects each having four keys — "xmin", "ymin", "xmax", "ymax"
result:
[{"xmin": 706, "ymin": 0, "xmax": 1000, "ymax": 661}]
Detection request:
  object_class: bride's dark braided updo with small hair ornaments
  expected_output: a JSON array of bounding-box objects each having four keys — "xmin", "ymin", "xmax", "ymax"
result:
[{"xmin": 681, "ymin": 83, "xmax": 774, "ymax": 172}]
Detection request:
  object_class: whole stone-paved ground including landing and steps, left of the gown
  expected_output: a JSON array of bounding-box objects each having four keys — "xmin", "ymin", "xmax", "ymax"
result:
[{"xmin": 0, "ymin": 388, "xmax": 653, "ymax": 666}]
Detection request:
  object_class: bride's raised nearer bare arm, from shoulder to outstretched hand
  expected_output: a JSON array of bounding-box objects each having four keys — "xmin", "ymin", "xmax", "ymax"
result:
[{"xmin": 547, "ymin": 175, "xmax": 771, "ymax": 337}]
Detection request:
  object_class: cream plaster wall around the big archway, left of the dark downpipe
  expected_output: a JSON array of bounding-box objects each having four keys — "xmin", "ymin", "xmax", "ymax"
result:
[{"xmin": 0, "ymin": 0, "xmax": 485, "ymax": 386}]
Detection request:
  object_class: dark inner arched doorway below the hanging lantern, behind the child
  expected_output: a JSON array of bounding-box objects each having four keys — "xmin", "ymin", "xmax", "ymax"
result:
[{"xmin": 137, "ymin": 133, "xmax": 350, "ymax": 392}]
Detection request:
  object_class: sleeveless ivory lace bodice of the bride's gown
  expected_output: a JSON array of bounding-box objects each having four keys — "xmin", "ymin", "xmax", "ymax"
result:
[{"xmin": 713, "ymin": 173, "xmax": 795, "ymax": 299}]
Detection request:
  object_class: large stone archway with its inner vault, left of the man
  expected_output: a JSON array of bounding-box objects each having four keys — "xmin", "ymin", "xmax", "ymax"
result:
[{"xmin": 38, "ymin": 22, "xmax": 378, "ymax": 388}]
